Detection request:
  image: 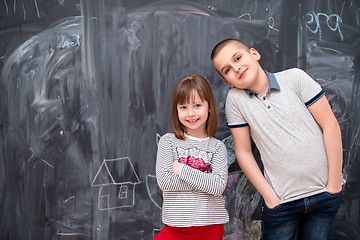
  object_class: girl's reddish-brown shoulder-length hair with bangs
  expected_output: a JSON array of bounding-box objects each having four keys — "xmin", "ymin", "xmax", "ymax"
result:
[{"xmin": 171, "ymin": 74, "xmax": 218, "ymax": 140}]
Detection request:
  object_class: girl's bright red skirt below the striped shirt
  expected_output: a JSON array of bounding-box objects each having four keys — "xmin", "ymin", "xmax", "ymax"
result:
[{"xmin": 153, "ymin": 224, "xmax": 224, "ymax": 240}]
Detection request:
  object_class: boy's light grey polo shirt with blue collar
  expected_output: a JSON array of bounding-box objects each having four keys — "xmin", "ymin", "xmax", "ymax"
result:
[{"xmin": 225, "ymin": 68, "xmax": 328, "ymax": 203}]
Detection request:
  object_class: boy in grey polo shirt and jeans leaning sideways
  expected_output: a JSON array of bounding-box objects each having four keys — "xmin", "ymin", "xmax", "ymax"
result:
[{"xmin": 211, "ymin": 39, "xmax": 343, "ymax": 240}]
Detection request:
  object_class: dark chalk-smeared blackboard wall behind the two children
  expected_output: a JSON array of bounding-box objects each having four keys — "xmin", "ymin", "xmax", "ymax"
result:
[{"xmin": 0, "ymin": 0, "xmax": 360, "ymax": 240}]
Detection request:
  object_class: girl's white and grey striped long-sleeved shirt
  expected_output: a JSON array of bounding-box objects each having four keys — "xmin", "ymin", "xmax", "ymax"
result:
[{"xmin": 156, "ymin": 133, "xmax": 229, "ymax": 227}]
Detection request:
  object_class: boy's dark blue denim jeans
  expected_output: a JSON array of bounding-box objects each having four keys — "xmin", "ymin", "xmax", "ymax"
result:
[{"xmin": 261, "ymin": 191, "xmax": 343, "ymax": 240}]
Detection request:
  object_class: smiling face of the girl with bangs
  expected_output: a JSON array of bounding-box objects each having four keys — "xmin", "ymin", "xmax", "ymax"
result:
[{"xmin": 177, "ymin": 91, "xmax": 209, "ymax": 138}]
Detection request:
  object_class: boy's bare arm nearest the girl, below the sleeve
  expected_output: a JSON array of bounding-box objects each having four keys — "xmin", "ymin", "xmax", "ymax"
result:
[{"xmin": 231, "ymin": 126, "xmax": 280, "ymax": 208}]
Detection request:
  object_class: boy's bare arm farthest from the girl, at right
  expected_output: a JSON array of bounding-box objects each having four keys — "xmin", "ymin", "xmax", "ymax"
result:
[{"xmin": 308, "ymin": 96, "xmax": 343, "ymax": 193}]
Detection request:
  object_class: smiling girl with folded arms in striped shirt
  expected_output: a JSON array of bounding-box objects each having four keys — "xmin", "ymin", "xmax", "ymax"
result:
[{"xmin": 153, "ymin": 75, "xmax": 229, "ymax": 240}]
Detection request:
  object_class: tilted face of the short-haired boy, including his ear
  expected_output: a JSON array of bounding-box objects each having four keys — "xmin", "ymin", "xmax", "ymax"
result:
[{"xmin": 212, "ymin": 42, "xmax": 260, "ymax": 89}]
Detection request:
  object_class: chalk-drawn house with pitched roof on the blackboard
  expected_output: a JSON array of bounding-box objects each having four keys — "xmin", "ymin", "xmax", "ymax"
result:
[{"xmin": 91, "ymin": 157, "xmax": 142, "ymax": 210}]
